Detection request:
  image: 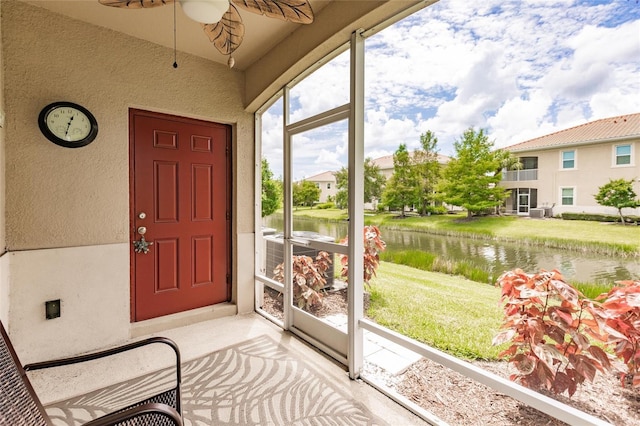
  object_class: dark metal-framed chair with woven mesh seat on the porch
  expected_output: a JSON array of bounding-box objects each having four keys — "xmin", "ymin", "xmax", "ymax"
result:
[{"xmin": 0, "ymin": 322, "xmax": 182, "ymax": 426}]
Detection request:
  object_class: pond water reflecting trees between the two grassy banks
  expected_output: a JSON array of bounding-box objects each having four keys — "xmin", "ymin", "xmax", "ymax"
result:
[{"xmin": 264, "ymin": 216, "xmax": 640, "ymax": 283}]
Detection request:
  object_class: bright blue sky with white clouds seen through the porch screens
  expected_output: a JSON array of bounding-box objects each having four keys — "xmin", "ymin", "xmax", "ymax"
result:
[{"xmin": 263, "ymin": 0, "xmax": 640, "ymax": 180}]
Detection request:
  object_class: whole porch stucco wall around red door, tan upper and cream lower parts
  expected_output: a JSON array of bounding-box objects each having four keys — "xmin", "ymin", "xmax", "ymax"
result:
[{"xmin": 0, "ymin": 2, "xmax": 254, "ymax": 358}]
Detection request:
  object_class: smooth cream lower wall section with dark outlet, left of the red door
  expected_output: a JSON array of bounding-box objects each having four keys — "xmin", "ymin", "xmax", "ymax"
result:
[{"xmin": 5, "ymin": 243, "xmax": 129, "ymax": 363}]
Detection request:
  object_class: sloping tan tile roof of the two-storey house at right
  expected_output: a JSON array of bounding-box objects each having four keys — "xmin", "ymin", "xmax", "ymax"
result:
[{"xmin": 505, "ymin": 113, "xmax": 640, "ymax": 151}]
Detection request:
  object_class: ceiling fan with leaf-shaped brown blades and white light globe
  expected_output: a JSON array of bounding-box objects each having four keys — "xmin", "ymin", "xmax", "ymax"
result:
[{"xmin": 98, "ymin": 0, "xmax": 313, "ymax": 67}]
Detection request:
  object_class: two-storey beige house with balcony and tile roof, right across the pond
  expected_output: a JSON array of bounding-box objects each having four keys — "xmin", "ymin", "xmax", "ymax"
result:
[{"xmin": 501, "ymin": 113, "xmax": 640, "ymax": 215}]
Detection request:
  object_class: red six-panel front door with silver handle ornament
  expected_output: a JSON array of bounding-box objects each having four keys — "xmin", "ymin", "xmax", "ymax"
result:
[{"xmin": 129, "ymin": 109, "xmax": 231, "ymax": 321}]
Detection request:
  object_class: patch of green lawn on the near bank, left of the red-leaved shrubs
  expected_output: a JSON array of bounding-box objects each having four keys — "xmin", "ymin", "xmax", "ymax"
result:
[{"xmin": 368, "ymin": 262, "xmax": 503, "ymax": 360}]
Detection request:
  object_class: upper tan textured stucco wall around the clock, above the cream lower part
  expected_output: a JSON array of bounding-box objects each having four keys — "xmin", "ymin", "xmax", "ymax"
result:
[{"xmin": 3, "ymin": 2, "xmax": 253, "ymax": 250}]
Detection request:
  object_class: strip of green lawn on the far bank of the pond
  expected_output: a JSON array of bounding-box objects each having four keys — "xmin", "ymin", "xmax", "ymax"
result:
[{"xmin": 294, "ymin": 208, "xmax": 640, "ymax": 256}]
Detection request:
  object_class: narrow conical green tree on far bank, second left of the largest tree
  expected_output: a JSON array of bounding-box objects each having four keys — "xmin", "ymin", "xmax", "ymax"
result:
[{"xmin": 382, "ymin": 144, "xmax": 419, "ymax": 217}]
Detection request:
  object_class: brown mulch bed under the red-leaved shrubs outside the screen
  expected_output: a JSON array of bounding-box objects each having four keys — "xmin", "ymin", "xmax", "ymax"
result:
[{"xmin": 263, "ymin": 288, "xmax": 640, "ymax": 426}]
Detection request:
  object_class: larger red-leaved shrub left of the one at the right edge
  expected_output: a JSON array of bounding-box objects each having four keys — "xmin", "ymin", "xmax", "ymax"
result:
[{"xmin": 493, "ymin": 269, "xmax": 611, "ymax": 396}]
